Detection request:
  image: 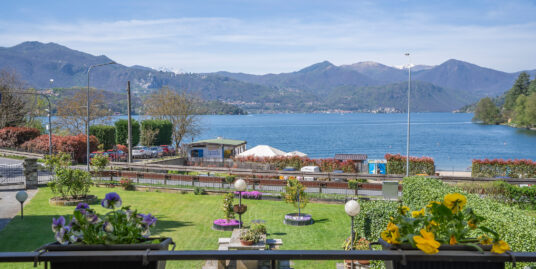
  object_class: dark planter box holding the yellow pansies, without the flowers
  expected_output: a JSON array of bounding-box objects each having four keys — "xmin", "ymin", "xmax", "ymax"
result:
[{"xmin": 378, "ymin": 238, "xmax": 505, "ymax": 269}]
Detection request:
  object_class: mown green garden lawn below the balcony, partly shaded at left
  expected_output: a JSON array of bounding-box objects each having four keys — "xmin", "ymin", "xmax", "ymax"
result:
[{"xmin": 0, "ymin": 188, "xmax": 350, "ymax": 268}]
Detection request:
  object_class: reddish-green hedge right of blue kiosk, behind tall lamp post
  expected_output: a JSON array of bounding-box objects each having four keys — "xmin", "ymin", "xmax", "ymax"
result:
[{"xmin": 385, "ymin": 154, "xmax": 435, "ymax": 175}]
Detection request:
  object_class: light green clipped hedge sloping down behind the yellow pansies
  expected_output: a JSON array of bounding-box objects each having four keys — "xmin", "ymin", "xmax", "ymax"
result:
[{"xmin": 402, "ymin": 176, "xmax": 536, "ymax": 252}]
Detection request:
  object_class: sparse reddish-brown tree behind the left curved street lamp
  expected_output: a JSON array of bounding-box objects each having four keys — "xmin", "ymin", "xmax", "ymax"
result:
[{"xmin": 56, "ymin": 89, "xmax": 111, "ymax": 134}]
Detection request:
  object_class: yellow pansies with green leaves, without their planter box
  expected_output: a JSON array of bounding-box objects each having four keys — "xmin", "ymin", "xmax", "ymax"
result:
[{"xmin": 381, "ymin": 193, "xmax": 510, "ymax": 254}]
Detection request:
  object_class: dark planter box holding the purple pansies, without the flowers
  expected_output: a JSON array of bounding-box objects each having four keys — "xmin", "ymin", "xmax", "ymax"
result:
[{"xmin": 43, "ymin": 238, "xmax": 175, "ymax": 269}]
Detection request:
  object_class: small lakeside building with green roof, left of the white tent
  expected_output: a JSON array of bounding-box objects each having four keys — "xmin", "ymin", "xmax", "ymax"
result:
[{"xmin": 187, "ymin": 137, "xmax": 247, "ymax": 161}]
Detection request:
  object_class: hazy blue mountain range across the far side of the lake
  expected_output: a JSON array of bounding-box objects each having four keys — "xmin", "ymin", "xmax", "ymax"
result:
[{"xmin": 0, "ymin": 41, "xmax": 536, "ymax": 112}]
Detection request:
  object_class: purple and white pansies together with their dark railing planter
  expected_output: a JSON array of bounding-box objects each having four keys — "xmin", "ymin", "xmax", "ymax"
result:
[{"xmin": 43, "ymin": 192, "xmax": 173, "ymax": 269}]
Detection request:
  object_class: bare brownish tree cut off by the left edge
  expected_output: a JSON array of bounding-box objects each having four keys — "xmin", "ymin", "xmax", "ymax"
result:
[{"xmin": 0, "ymin": 70, "xmax": 28, "ymax": 129}]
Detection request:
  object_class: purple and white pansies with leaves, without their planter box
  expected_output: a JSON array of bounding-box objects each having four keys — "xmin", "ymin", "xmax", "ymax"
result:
[{"xmin": 52, "ymin": 189, "xmax": 156, "ymax": 245}]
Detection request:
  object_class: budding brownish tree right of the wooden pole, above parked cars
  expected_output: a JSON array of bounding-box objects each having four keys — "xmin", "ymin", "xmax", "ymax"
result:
[{"xmin": 144, "ymin": 87, "xmax": 201, "ymax": 149}]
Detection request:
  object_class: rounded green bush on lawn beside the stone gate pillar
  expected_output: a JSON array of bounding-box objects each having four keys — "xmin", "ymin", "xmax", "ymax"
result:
[{"xmin": 48, "ymin": 167, "xmax": 92, "ymax": 199}]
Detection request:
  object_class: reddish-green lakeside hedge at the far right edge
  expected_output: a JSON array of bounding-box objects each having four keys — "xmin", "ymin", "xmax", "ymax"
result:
[{"xmin": 471, "ymin": 159, "xmax": 536, "ymax": 178}]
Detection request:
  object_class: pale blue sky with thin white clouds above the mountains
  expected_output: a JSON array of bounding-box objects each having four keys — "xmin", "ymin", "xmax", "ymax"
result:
[{"xmin": 0, "ymin": 0, "xmax": 536, "ymax": 74}]
